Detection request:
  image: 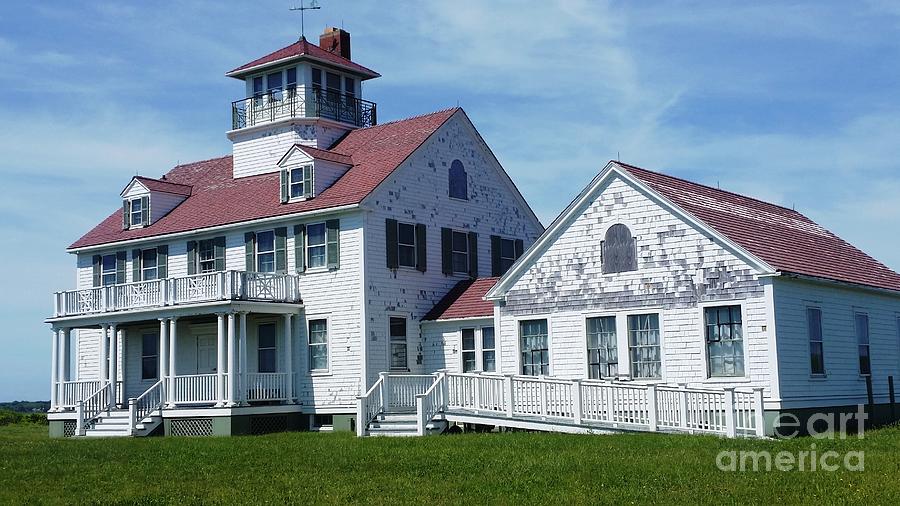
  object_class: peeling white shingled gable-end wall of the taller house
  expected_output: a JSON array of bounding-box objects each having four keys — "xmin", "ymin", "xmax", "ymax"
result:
[{"xmin": 365, "ymin": 114, "xmax": 542, "ymax": 384}]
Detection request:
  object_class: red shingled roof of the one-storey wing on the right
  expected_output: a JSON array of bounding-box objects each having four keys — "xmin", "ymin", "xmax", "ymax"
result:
[{"xmin": 616, "ymin": 162, "xmax": 900, "ymax": 291}]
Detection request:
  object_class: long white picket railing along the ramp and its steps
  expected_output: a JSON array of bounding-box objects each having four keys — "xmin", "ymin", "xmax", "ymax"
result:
[{"xmin": 357, "ymin": 373, "xmax": 765, "ymax": 437}]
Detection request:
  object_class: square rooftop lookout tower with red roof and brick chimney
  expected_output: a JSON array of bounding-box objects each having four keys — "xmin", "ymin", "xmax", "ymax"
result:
[{"xmin": 225, "ymin": 27, "xmax": 380, "ymax": 177}]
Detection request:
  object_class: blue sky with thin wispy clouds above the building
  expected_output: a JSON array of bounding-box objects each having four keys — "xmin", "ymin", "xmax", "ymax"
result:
[{"xmin": 0, "ymin": 0, "xmax": 900, "ymax": 401}]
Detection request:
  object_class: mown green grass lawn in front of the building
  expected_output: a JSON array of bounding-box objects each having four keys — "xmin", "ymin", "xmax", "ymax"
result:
[{"xmin": 0, "ymin": 424, "xmax": 900, "ymax": 505}]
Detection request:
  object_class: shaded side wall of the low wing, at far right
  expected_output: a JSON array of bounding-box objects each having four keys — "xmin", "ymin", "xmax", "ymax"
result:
[{"xmin": 774, "ymin": 277, "xmax": 900, "ymax": 406}]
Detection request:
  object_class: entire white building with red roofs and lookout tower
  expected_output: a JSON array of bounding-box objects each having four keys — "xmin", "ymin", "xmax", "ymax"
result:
[{"xmin": 48, "ymin": 29, "xmax": 900, "ymax": 437}]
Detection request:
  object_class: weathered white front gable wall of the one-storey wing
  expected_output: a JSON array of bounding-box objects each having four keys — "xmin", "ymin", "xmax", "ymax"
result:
[{"xmin": 499, "ymin": 174, "xmax": 773, "ymax": 387}]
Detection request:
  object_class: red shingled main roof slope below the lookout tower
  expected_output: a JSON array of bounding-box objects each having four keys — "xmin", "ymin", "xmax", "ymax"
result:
[{"xmin": 69, "ymin": 108, "xmax": 460, "ymax": 248}]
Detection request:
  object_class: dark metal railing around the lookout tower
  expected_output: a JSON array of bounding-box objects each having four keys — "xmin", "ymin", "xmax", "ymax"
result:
[{"xmin": 231, "ymin": 86, "xmax": 377, "ymax": 130}]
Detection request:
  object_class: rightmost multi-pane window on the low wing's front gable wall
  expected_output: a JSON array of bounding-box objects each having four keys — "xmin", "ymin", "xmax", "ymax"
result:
[{"xmin": 704, "ymin": 306, "xmax": 744, "ymax": 377}]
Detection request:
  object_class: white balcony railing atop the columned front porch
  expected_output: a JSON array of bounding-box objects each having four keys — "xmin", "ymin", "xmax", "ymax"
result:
[{"xmin": 53, "ymin": 271, "xmax": 300, "ymax": 317}]
